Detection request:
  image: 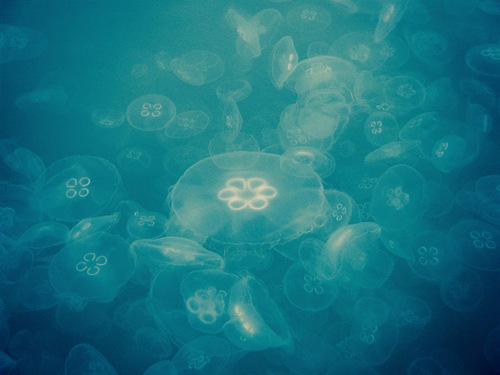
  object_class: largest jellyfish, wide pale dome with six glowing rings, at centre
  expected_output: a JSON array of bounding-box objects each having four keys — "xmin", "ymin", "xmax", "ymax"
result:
[{"xmin": 170, "ymin": 152, "xmax": 325, "ymax": 245}]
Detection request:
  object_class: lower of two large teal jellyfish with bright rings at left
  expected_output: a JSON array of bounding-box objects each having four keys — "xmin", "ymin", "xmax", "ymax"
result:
[{"xmin": 50, "ymin": 232, "xmax": 136, "ymax": 305}]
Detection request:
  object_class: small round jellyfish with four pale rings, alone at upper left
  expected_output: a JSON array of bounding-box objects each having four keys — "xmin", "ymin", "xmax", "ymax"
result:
[{"xmin": 127, "ymin": 94, "xmax": 177, "ymax": 131}]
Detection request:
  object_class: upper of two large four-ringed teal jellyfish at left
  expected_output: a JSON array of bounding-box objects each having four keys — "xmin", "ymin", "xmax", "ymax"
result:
[{"xmin": 42, "ymin": 155, "xmax": 121, "ymax": 222}]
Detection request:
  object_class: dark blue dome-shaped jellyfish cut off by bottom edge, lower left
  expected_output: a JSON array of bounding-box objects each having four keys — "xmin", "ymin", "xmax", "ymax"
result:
[{"xmin": 64, "ymin": 344, "xmax": 118, "ymax": 375}]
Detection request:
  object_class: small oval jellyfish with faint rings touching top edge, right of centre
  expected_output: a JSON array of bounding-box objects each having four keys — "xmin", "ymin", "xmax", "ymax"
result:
[{"xmin": 286, "ymin": 3, "xmax": 332, "ymax": 34}]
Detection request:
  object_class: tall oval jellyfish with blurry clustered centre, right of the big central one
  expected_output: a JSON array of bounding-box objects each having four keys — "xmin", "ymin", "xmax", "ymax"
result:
[{"xmin": 370, "ymin": 165, "xmax": 425, "ymax": 232}]
